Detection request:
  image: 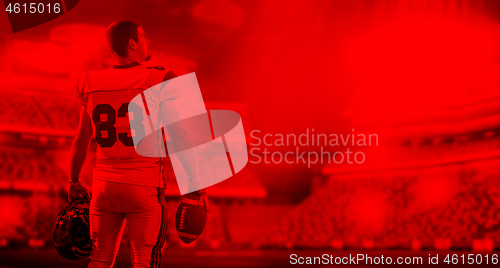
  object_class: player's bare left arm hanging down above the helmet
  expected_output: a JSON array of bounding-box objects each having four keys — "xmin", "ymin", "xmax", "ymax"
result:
[{"xmin": 68, "ymin": 106, "xmax": 93, "ymax": 201}]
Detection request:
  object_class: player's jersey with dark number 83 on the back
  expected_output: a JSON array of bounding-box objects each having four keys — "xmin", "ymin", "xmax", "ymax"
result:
[{"xmin": 77, "ymin": 63, "xmax": 164, "ymax": 187}]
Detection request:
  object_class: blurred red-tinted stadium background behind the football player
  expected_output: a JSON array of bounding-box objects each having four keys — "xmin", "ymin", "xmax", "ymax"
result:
[{"xmin": 0, "ymin": 0, "xmax": 500, "ymax": 267}]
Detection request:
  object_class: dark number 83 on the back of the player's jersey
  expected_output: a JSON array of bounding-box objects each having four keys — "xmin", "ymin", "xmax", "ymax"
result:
[{"xmin": 92, "ymin": 102, "xmax": 146, "ymax": 147}]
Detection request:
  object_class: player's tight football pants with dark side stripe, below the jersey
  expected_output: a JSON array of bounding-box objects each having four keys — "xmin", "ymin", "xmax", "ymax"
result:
[{"xmin": 88, "ymin": 180, "xmax": 167, "ymax": 268}]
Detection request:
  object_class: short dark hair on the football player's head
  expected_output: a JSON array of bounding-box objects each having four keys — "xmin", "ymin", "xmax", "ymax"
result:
[{"xmin": 106, "ymin": 20, "xmax": 142, "ymax": 58}]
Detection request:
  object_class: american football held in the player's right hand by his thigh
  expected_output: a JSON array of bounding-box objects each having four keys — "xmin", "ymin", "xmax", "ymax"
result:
[{"xmin": 175, "ymin": 193, "xmax": 207, "ymax": 244}]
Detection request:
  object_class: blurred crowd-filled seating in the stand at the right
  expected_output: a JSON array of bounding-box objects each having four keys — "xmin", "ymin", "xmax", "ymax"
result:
[{"xmin": 260, "ymin": 144, "xmax": 500, "ymax": 249}]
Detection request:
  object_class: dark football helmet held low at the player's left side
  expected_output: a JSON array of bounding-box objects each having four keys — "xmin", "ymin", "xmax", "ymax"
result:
[{"xmin": 53, "ymin": 198, "xmax": 92, "ymax": 260}]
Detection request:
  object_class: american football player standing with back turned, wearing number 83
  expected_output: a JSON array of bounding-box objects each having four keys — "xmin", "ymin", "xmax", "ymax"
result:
[{"xmin": 68, "ymin": 20, "xmax": 209, "ymax": 267}]
